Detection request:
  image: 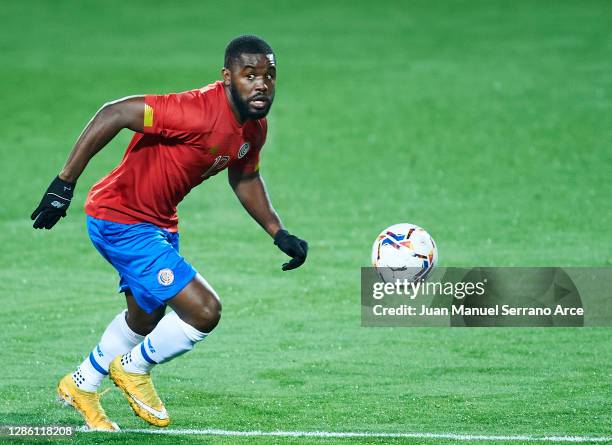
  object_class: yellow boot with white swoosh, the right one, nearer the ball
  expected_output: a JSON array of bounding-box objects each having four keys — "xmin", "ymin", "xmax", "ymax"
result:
[{"xmin": 108, "ymin": 356, "xmax": 170, "ymax": 426}]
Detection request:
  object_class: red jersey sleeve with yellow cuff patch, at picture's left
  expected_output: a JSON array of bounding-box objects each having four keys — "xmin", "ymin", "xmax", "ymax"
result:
[{"xmin": 143, "ymin": 90, "xmax": 208, "ymax": 142}]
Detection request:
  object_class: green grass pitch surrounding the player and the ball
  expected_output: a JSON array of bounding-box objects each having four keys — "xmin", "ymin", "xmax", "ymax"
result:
[{"xmin": 0, "ymin": 0, "xmax": 612, "ymax": 445}]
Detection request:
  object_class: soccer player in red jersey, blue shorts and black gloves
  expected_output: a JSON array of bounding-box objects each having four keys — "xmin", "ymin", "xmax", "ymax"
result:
[{"xmin": 31, "ymin": 36, "xmax": 308, "ymax": 431}]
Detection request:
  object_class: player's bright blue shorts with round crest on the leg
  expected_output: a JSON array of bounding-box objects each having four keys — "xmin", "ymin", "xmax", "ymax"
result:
[{"xmin": 87, "ymin": 216, "xmax": 196, "ymax": 313}]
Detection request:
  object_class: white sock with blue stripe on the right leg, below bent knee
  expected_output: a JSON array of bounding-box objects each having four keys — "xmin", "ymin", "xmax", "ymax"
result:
[{"xmin": 121, "ymin": 312, "xmax": 208, "ymax": 374}]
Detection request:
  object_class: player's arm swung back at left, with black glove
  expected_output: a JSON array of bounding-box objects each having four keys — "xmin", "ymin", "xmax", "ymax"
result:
[{"xmin": 31, "ymin": 96, "xmax": 145, "ymax": 229}]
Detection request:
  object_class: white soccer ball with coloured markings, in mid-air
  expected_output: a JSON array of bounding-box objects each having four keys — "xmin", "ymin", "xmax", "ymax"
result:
[{"xmin": 372, "ymin": 223, "xmax": 438, "ymax": 282}]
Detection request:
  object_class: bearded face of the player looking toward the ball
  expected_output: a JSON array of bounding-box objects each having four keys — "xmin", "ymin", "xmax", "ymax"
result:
[{"xmin": 223, "ymin": 54, "xmax": 276, "ymax": 121}]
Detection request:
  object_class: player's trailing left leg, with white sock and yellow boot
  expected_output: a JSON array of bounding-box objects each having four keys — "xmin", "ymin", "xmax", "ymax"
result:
[{"xmin": 57, "ymin": 290, "xmax": 166, "ymax": 431}]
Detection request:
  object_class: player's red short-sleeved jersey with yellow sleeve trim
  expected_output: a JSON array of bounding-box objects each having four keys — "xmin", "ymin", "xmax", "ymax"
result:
[{"xmin": 85, "ymin": 81, "xmax": 267, "ymax": 232}]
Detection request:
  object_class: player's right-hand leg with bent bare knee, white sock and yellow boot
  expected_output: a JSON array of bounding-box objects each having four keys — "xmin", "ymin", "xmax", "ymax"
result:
[{"xmin": 109, "ymin": 274, "xmax": 221, "ymax": 426}]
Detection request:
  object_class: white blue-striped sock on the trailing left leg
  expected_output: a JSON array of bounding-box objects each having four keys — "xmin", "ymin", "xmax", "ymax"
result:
[{"xmin": 72, "ymin": 310, "xmax": 144, "ymax": 392}]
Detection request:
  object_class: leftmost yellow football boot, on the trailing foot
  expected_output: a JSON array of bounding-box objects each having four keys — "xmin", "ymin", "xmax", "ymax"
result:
[{"xmin": 57, "ymin": 374, "xmax": 119, "ymax": 431}]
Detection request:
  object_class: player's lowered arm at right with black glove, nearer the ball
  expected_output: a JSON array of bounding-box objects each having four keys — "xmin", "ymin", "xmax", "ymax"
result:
[{"xmin": 228, "ymin": 166, "xmax": 308, "ymax": 270}]
